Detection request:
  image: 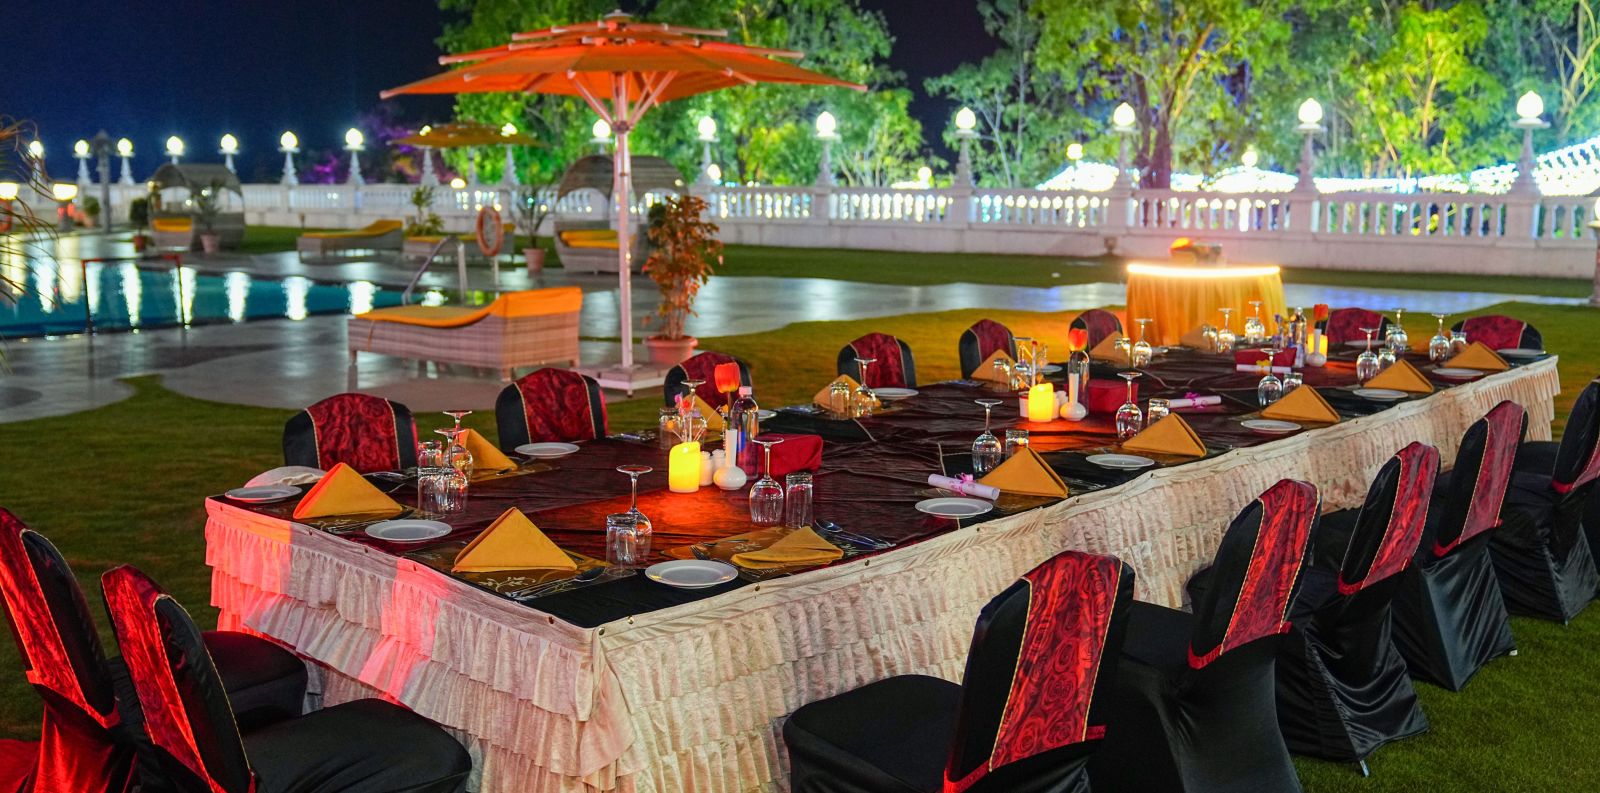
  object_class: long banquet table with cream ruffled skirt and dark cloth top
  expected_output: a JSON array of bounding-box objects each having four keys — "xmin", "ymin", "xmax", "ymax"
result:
[{"xmin": 206, "ymin": 350, "xmax": 1560, "ymax": 791}]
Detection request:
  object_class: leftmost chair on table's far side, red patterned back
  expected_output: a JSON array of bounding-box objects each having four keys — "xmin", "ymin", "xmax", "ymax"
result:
[{"xmin": 283, "ymin": 393, "xmax": 416, "ymax": 473}]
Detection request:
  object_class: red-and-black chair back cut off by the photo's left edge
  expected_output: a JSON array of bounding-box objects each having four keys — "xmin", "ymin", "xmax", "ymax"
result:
[{"xmin": 0, "ymin": 508, "xmax": 133, "ymax": 793}]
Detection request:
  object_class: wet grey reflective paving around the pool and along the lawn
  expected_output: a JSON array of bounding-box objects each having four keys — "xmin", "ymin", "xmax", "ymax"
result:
[{"xmin": 0, "ymin": 238, "xmax": 1581, "ymax": 422}]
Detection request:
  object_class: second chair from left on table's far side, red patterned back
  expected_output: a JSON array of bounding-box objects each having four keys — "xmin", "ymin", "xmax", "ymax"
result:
[{"xmin": 494, "ymin": 369, "xmax": 608, "ymax": 452}]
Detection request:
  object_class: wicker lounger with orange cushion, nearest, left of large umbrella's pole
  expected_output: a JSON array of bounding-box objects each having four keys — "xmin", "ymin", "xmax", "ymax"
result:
[{"xmin": 347, "ymin": 286, "xmax": 584, "ymax": 381}]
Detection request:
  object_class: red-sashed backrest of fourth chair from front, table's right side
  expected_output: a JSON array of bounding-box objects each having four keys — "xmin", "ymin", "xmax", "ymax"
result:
[{"xmin": 1432, "ymin": 400, "xmax": 1528, "ymax": 558}]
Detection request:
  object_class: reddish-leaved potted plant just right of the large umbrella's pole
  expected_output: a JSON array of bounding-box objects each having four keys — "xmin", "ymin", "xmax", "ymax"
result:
[{"xmin": 645, "ymin": 195, "xmax": 722, "ymax": 366}]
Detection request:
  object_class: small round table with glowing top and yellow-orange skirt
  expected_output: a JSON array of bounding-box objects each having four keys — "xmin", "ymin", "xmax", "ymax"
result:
[{"xmin": 1126, "ymin": 262, "xmax": 1288, "ymax": 344}]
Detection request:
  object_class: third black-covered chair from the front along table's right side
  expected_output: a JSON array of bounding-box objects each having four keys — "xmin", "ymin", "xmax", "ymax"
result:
[{"xmin": 1277, "ymin": 443, "xmax": 1438, "ymax": 774}]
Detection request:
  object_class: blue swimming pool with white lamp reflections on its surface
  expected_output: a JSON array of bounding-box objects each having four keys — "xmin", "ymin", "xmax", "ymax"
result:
[{"xmin": 0, "ymin": 262, "xmax": 412, "ymax": 339}]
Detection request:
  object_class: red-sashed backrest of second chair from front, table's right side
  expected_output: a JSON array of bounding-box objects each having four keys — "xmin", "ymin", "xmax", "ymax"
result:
[{"xmin": 1189, "ymin": 480, "xmax": 1322, "ymax": 668}]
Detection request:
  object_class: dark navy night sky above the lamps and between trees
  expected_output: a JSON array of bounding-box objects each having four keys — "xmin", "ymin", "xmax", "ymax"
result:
[{"xmin": 9, "ymin": 0, "xmax": 994, "ymax": 181}]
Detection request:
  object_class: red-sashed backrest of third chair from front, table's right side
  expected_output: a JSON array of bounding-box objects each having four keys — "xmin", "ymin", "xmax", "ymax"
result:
[{"xmin": 1339, "ymin": 443, "xmax": 1438, "ymax": 595}]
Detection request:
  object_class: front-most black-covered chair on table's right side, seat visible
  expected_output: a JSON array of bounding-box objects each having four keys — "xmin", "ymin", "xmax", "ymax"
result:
[{"xmin": 784, "ymin": 552, "xmax": 1133, "ymax": 793}]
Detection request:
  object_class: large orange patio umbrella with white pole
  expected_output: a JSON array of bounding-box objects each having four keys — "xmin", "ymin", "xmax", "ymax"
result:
[{"xmin": 382, "ymin": 11, "xmax": 866, "ymax": 382}]
